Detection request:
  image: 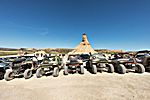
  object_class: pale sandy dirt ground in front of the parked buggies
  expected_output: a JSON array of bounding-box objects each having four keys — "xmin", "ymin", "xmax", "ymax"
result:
[{"xmin": 0, "ymin": 71, "xmax": 150, "ymax": 100}]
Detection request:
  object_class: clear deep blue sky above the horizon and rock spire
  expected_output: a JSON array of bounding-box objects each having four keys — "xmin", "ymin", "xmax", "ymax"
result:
[{"xmin": 0, "ymin": 0, "xmax": 150, "ymax": 51}]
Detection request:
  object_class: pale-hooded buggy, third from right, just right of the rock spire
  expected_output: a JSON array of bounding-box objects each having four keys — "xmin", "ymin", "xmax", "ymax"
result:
[{"xmin": 86, "ymin": 54, "xmax": 114, "ymax": 74}]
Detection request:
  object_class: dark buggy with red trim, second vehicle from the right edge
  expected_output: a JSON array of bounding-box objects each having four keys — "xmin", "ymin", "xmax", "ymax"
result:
[{"xmin": 112, "ymin": 53, "xmax": 145, "ymax": 74}]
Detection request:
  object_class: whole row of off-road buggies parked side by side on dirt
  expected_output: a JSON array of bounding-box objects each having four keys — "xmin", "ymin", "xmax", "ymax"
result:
[{"xmin": 1, "ymin": 52, "xmax": 150, "ymax": 81}]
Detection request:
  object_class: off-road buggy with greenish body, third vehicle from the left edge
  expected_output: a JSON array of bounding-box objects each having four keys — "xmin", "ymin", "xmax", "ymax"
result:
[{"xmin": 36, "ymin": 55, "xmax": 62, "ymax": 78}]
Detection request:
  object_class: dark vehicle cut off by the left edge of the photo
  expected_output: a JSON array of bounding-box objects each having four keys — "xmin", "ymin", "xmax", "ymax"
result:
[{"xmin": 0, "ymin": 60, "xmax": 9, "ymax": 80}]
